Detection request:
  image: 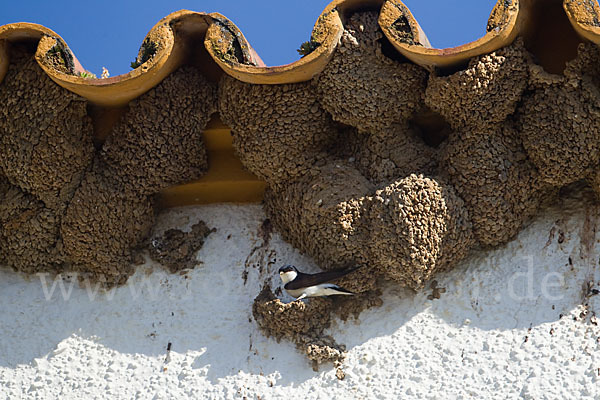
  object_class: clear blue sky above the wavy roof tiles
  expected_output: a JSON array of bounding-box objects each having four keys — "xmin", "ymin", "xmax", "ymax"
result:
[{"xmin": 0, "ymin": 0, "xmax": 496, "ymax": 76}]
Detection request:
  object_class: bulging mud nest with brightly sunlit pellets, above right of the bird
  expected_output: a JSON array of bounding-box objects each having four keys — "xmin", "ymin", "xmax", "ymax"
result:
[{"xmin": 369, "ymin": 175, "xmax": 473, "ymax": 289}]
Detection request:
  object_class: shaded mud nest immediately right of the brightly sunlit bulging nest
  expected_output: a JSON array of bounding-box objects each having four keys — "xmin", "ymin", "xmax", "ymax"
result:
[{"xmin": 444, "ymin": 123, "xmax": 546, "ymax": 246}]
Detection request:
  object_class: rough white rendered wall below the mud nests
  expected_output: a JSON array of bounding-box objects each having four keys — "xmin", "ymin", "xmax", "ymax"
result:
[{"xmin": 0, "ymin": 193, "xmax": 600, "ymax": 399}]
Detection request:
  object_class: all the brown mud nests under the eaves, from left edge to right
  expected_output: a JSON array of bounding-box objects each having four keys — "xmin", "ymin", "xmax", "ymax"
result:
[{"xmin": 0, "ymin": 12, "xmax": 600, "ymax": 368}]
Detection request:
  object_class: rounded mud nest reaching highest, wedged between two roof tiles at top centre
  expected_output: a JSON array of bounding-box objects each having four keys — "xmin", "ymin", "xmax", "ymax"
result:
[{"xmin": 314, "ymin": 12, "xmax": 427, "ymax": 132}]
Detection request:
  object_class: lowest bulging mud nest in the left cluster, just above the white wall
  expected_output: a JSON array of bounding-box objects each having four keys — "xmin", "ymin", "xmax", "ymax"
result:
[{"xmin": 61, "ymin": 167, "xmax": 154, "ymax": 286}]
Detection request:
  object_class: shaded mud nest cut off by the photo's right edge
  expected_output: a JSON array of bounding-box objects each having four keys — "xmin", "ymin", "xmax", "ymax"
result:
[{"xmin": 518, "ymin": 43, "xmax": 600, "ymax": 187}]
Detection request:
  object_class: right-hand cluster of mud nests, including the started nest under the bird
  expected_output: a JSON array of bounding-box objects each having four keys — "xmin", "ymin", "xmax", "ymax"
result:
[{"xmin": 219, "ymin": 12, "xmax": 600, "ymax": 362}]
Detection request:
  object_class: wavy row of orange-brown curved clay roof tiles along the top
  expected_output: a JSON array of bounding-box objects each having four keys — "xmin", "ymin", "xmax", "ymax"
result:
[{"xmin": 0, "ymin": 0, "xmax": 600, "ymax": 107}]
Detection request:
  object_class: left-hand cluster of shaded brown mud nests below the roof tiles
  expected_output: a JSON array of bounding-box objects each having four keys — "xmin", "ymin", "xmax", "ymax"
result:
[{"xmin": 0, "ymin": 45, "xmax": 217, "ymax": 286}]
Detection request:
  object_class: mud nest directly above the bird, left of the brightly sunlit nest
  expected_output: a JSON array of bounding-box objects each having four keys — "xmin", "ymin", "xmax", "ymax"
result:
[{"xmin": 265, "ymin": 161, "xmax": 374, "ymax": 274}]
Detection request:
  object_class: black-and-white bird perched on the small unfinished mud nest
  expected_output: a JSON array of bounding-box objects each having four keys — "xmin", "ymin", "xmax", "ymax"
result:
[{"xmin": 279, "ymin": 265, "xmax": 358, "ymax": 300}]
